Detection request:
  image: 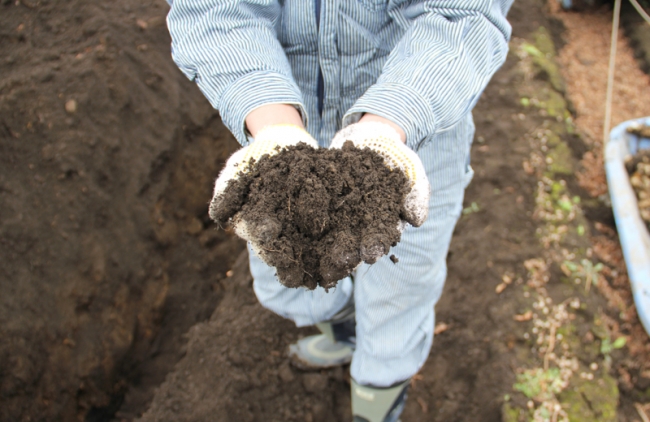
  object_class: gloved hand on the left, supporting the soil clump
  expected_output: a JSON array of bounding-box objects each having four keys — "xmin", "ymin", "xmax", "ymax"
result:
[{"xmin": 209, "ymin": 124, "xmax": 318, "ymax": 251}]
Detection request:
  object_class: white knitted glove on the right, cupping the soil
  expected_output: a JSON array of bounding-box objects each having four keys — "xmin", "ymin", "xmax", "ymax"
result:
[{"xmin": 330, "ymin": 122, "xmax": 430, "ymax": 230}]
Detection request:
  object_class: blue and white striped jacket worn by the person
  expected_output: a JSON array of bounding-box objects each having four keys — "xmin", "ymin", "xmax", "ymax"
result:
[{"xmin": 167, "ymin": 0, "xmax": 513, "ymax": 149}]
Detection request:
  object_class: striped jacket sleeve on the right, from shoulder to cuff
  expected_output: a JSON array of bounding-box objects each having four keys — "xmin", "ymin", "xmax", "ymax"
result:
[{"xmin": 343, "ymin": 0, "xmax": 512, "ymax": 149}]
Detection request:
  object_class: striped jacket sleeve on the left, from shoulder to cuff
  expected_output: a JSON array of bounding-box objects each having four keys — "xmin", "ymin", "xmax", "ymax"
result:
[{"xmin": 167, "ymin": 0, "xmax": 307, "ymax": 145}]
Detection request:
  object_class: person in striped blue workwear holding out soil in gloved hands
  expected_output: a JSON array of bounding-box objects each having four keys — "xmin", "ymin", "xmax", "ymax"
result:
[{"xmin": 167, "ymin": 0, "xmax": 513, "ymax": 422}]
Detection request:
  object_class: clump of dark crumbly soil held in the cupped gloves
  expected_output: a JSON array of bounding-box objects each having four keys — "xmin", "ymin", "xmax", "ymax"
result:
[{"xmin": 210, "ymin": 142, "xmax": 410, "ymax": 289}]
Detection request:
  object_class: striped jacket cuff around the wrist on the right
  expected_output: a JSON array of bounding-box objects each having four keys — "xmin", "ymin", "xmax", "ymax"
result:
[{"xmin": 342, "ymin": 83, "xmax": 436, "ymax": 150}]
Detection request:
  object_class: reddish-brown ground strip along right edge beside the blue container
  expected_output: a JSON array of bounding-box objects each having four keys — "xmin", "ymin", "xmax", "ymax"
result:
[{"xmin": 549, "ymin": 1, "xmax": 650, "ymax": 421}]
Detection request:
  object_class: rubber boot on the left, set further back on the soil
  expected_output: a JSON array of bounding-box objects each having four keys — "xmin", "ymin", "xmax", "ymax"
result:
[{"xmin": 289, "ymin": 297, "xmax": 356, "ymax": 370}]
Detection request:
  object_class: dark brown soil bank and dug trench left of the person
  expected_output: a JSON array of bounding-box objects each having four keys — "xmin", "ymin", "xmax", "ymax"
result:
[{"xmin": 0, "ymin": 0, "xmax": 244, "ymax": 422}]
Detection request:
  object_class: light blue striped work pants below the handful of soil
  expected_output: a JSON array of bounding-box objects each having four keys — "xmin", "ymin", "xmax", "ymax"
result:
[{"xmin": 249, "ymin": 114, "xmax": 474, "ymax": 387}]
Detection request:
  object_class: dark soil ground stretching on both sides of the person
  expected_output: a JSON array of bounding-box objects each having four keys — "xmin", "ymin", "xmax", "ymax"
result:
[{"xmin": 0, "ymin": 0, "xmax": 650, "ymax": 422}]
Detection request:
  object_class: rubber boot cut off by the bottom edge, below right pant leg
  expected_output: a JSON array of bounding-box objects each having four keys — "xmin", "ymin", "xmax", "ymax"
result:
[{"xmin": 350, "ymin": 379, "xmax": 411, "ymax": 422}]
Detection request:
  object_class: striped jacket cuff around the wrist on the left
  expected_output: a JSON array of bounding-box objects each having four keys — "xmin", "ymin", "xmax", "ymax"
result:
[{"xmin": 197, "ymin": 71, "xmax": 307, "ymax": 146}]
